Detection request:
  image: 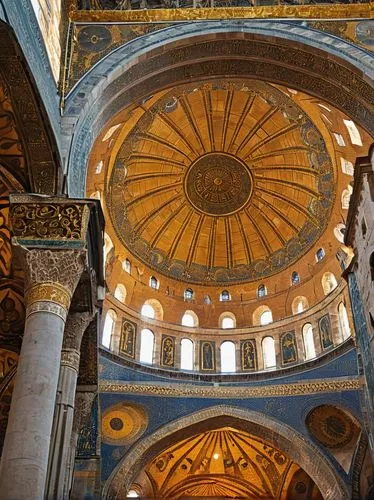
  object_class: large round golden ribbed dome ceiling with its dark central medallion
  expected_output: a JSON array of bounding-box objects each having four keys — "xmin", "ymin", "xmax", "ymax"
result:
[{"xmin": 106, "ymin": 80, "xmax": 334, "ymax": 285}]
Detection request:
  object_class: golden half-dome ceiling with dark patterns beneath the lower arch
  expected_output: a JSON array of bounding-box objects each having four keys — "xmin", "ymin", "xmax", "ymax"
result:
[{"xmin": 140, "ymin": 427, "xmax": 322, "ymax": 499}]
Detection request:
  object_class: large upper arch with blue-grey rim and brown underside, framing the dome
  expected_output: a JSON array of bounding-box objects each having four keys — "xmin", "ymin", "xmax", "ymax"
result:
[{"xmin": 63, "ymin": 20, "xmax": 374, "ymax": 196}]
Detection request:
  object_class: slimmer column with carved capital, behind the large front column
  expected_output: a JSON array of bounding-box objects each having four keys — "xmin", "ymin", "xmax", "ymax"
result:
[{"xmin": 46, "ymin": 312, "xmax": 93, "ymax": 499}]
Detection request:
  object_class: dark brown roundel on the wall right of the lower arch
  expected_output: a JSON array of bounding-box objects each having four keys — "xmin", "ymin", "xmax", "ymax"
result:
[{"xmin": 306, "ymin": 405, "xmax": 354, "ymax": 448}]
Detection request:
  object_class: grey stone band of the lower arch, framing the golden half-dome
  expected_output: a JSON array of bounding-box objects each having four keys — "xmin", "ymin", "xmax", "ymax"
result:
[{"xmin": 103, "ymin": 405, "xmax": 350, "ymax": 500}]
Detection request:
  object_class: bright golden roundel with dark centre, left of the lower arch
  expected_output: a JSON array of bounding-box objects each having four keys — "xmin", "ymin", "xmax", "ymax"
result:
[{"xmin": 101, "ymin": 402, "xmax": 148, "ymax": 446}]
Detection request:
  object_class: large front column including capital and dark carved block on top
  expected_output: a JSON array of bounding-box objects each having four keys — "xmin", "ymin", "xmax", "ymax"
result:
[{"xmin": 0, "ymin": 194, "xmax": 90, "ymax": 500}]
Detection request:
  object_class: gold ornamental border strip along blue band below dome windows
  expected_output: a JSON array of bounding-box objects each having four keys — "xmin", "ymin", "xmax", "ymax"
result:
[{"xmin": 99, "ymin": 378, "xmax": 360, "ymax": 399}]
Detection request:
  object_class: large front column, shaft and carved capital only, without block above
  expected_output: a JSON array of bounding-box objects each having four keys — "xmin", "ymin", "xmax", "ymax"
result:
[{"xmin": 0, "ymin": 248, "xmax": 86, "ymax": 500}]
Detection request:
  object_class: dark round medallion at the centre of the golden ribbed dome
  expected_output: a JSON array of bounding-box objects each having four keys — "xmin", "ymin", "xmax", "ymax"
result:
[{"xmin": 184, "ymin": 153, "xmax": 253, "ymax": 216}]
